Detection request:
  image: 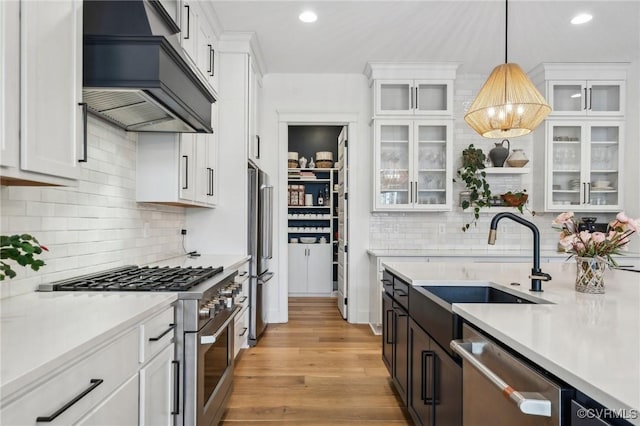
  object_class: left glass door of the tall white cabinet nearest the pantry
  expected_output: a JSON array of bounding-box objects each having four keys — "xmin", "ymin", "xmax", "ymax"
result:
[{"xmin": 376, "ymin": 121, "xmax": 413, "ymax": 208}]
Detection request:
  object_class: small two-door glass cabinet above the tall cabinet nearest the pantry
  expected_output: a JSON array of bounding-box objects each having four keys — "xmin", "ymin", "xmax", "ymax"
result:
[{"xmin": 374, "ymin": 80, "xmax": 453, "ymax": 115}]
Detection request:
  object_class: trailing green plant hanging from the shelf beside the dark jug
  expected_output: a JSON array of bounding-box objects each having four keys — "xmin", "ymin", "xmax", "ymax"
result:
[{"xmin": 458, "ymin": 144, "xmax": 491, "ymax": 232}]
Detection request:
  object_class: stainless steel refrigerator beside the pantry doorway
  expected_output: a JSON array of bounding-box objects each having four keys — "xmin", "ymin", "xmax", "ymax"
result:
[{"xmin": 247, "ymin": 162, "xmax": 273, "ymax": 346}]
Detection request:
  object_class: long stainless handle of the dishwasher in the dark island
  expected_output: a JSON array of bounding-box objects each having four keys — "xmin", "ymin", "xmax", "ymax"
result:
[{"xmin": 450, "ymin": 340, "xmax": 551, "ymax": 417}]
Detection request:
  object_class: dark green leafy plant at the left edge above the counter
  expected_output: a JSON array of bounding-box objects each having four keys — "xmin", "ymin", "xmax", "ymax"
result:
[{"xmin": 0, "ymin": 234, "xmax": 49, "ymax": 281}]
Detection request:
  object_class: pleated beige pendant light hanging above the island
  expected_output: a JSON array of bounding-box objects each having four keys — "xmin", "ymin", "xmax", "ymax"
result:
[{"xmin": 464, "ymin": 0, "xmax": 551, "ymax": 139}]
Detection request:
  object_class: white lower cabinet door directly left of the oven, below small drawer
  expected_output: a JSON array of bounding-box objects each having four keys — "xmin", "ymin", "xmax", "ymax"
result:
[{"xmin": 139, "ymin": 344, "xmax": 175, "ymax": 426}]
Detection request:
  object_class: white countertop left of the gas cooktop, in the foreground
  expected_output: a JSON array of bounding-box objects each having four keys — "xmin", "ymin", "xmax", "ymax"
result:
[{"xmin": 0, "ymin": 292, "xmax": 177, "ymax": 399}]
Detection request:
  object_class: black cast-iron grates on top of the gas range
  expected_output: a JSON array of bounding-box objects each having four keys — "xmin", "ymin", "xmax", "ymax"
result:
[{"xmin": 52, "ymin": 266, "xmax": 223, "ymax": 291}]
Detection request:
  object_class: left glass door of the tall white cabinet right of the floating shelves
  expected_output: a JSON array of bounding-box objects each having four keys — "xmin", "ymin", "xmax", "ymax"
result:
[{"xmin": 547, "ymin": 123, "xmax": 586, "ymax": 210}]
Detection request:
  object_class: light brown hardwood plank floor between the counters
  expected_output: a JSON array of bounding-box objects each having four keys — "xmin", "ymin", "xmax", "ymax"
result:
[{"xmin": 221, "ymin": 298, "xmax": 411, "ymax": 425}]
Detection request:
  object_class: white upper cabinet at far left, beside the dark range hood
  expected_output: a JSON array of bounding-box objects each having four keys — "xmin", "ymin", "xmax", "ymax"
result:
[{"xmin": 1, "ymin": 1, "xmax": 87, "ymax": 185}]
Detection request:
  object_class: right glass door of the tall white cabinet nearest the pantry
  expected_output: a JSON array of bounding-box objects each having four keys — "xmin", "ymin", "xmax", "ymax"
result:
[{"xmin": 414, "ymin": 123, "xmax": 448, "ymax": 207}]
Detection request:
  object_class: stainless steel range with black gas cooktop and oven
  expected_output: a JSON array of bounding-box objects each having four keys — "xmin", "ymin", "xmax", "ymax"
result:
[{"xmin": 40, "ymin": 266, "xmax": 242, "ymax": 426}]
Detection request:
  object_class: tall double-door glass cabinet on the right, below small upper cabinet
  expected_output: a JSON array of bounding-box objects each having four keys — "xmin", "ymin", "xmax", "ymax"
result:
[{"xmin": 545, "ymin": 120, "xmax": 624, "ymax": 211}]
